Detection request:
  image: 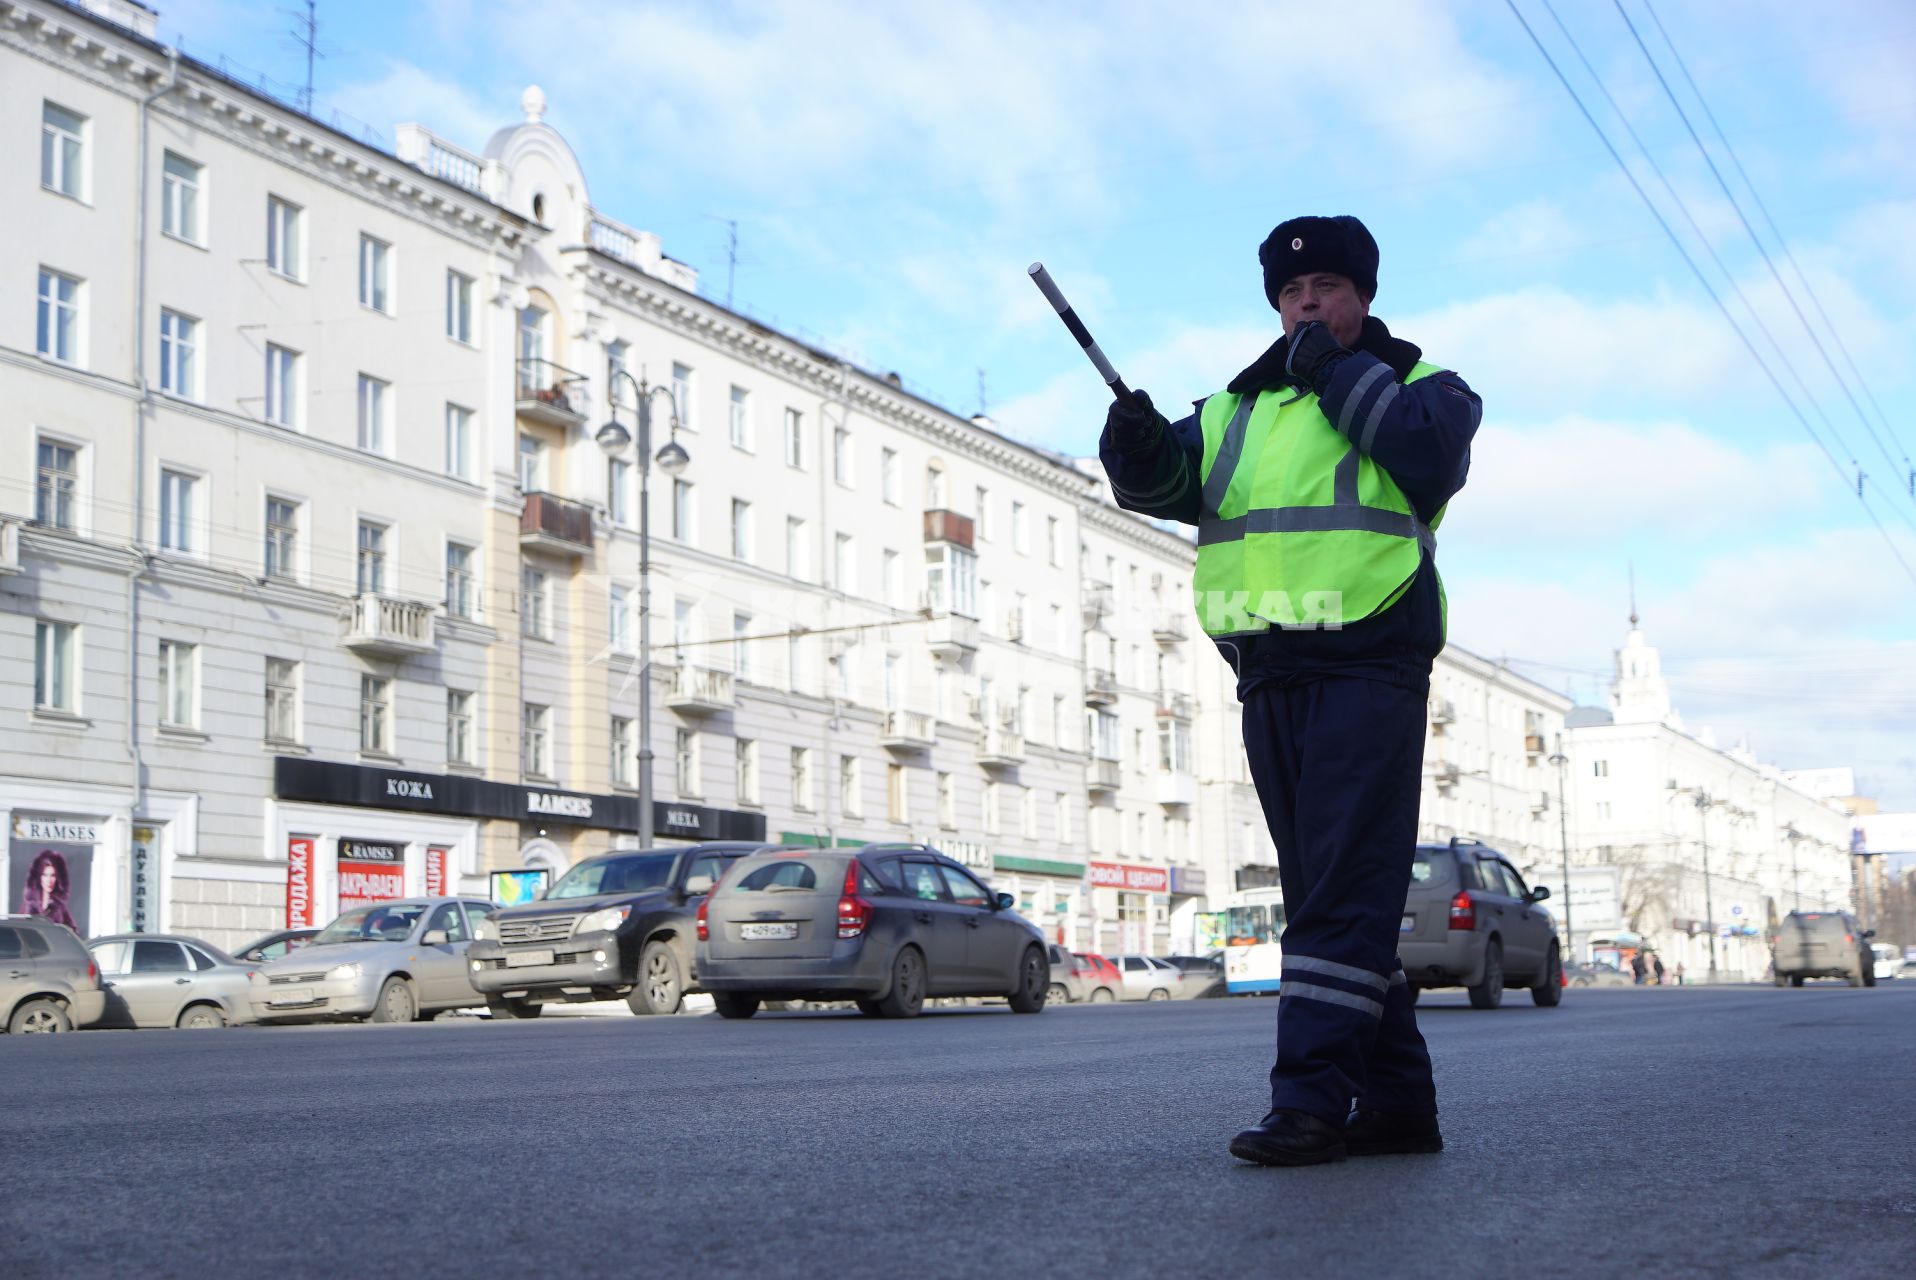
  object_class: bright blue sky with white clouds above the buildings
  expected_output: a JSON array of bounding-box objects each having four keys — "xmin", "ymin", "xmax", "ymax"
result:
[{"xmin": 157, "ymin": 0, "xmax": 1916, "ymax": 811}]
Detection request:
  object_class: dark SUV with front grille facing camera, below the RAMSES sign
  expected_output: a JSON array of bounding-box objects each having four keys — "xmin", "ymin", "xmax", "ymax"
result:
[{"xmin": 466, "ymin": 841, "xmax": 778, "ymax": 1017}]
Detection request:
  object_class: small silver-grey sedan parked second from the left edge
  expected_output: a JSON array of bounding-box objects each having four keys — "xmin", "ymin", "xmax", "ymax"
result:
[{"xmin": 86, "ymin": 933, "xmax": 253, "ymax": 1029}]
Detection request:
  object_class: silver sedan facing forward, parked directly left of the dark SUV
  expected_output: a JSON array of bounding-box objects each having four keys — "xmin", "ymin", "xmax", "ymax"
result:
[{"xmin": 253, "ymin": 899, "xmax": 494, "ymax": 1021}]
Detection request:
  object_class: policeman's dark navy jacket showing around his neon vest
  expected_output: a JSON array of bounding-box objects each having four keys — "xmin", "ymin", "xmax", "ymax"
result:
[{"xmin": 1098, "ymin": 316, "xmax": 1483, "ymax": 697}]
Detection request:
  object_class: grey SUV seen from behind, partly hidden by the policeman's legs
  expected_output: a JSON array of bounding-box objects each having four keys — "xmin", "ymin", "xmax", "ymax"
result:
[{"xmin": 1397, "ymin": 839, "xmax": 1563, "ymax": 1010}]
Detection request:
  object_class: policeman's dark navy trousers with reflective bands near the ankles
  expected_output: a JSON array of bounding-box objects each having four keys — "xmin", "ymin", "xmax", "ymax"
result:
[{"xmin": 1243, "ymin": 676, "xmax": 1437, "ymax": 1125}]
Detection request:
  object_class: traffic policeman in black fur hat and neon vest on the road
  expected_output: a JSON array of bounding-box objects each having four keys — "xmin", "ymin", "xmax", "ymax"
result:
[{"xmin": 1100, "ymin": 217, "xmax": 1481, "ymax": 1165}]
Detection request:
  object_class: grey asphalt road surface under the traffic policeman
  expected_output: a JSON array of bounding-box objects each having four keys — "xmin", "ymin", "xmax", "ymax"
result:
[{"xmin": 0, "ymin": 983, "xmax": 1916, "ymax": 1280}]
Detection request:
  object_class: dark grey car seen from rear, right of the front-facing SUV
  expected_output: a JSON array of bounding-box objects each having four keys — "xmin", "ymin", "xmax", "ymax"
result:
[{"xmin": 697, "ymin": 845, "xmax": 1052, "ymax": 1017}]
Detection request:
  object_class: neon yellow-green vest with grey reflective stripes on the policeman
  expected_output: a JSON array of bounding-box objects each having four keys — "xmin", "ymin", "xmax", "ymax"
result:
[{"xmin": 1192, "ymin": 362, "xmax": 1443, "ymax": 636}]
